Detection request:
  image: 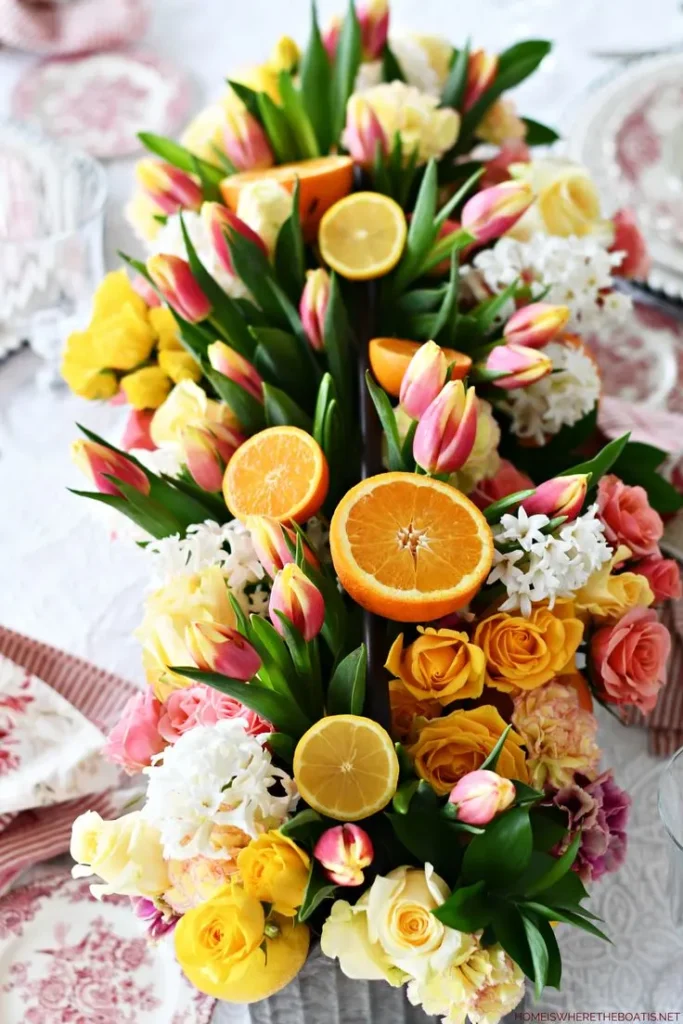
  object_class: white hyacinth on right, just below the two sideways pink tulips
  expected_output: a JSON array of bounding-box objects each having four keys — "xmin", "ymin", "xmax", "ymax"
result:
[{"xmin": 500, "ymin": 341, "xmax": 600, "ymax": 444}]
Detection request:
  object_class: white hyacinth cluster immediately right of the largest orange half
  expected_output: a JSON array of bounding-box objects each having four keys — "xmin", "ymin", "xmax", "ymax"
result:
[{"xmin": 486, "ymin": 505, "xmax": 612, "ymax": 616}]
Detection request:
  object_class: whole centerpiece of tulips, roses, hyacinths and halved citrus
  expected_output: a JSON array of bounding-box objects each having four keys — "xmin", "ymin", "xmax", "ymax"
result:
[{"xmin": 63, "ymin": 0, "xmax": 682, "ymax": 1024}]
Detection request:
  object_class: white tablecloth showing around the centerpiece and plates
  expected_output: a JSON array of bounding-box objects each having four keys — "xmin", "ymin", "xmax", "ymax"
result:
[{"xmin": 0, "ymin": 0, "xmax": 683, "ymax": 1012}]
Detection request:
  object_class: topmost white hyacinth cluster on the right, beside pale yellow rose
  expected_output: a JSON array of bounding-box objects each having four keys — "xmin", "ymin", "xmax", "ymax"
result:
[{"xmin": 463, "ymin": 234, "xmax": 633, "ymax": 334}]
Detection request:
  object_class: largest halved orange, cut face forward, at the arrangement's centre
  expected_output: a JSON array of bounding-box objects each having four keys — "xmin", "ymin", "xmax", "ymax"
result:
[{"xmin": 330, "ymin": 473, "xmax": 494, "ymax": 623}]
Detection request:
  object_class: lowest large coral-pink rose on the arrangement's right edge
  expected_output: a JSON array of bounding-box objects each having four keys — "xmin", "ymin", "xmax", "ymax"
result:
[{"xmin": 591, "ymin": 608, "xmax": 671, "ymax": 714}]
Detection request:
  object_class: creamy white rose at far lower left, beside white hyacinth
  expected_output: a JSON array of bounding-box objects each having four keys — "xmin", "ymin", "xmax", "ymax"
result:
[{"xmin": 71, "ymin": 811, "xmax": 169, "ymax": 899}]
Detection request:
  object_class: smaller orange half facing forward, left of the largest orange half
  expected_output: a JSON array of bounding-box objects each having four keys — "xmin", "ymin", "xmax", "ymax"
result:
[{"xmin": 223, "ymin": 427, "xmax": 330, "ymax": 522}]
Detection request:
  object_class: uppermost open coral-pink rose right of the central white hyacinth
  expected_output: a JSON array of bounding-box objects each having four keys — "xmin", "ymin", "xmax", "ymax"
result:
[{"xmin": 598, "ymin": 474, "xmax": 664, "ymax": 558}]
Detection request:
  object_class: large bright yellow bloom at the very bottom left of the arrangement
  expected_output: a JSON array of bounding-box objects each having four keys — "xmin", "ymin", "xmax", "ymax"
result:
[{"xmin": 174, "ymin": 880, "xmax": 309, "ymax": 1002}]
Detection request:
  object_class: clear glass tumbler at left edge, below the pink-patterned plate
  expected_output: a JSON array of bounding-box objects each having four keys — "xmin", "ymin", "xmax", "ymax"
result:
[{"xmin": 0, "ymin": 121, "xmax": 106, "ymax": 374}]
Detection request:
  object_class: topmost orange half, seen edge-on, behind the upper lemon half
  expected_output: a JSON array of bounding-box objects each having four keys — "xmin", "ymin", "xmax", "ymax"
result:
[{"xmin": 220, "ymin": 156, "xmax": 353, "ymax": 241}]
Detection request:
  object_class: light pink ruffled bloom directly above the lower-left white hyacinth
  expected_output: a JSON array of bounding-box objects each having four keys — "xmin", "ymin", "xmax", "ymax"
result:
[{"xmin": 159, "ymin": 683, "xmax": 272, "ymax": 743}]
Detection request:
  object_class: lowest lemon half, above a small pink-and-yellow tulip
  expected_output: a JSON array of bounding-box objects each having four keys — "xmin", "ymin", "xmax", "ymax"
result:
[{"xmin": 294, "ymin": 715, "xmax": 398, "ymax": 821}]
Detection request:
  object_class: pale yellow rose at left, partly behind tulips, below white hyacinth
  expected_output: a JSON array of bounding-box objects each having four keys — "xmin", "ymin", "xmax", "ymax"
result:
[{"xmin": 135, "ymin": 565, "xmax": 236, "ymax": 700}]
